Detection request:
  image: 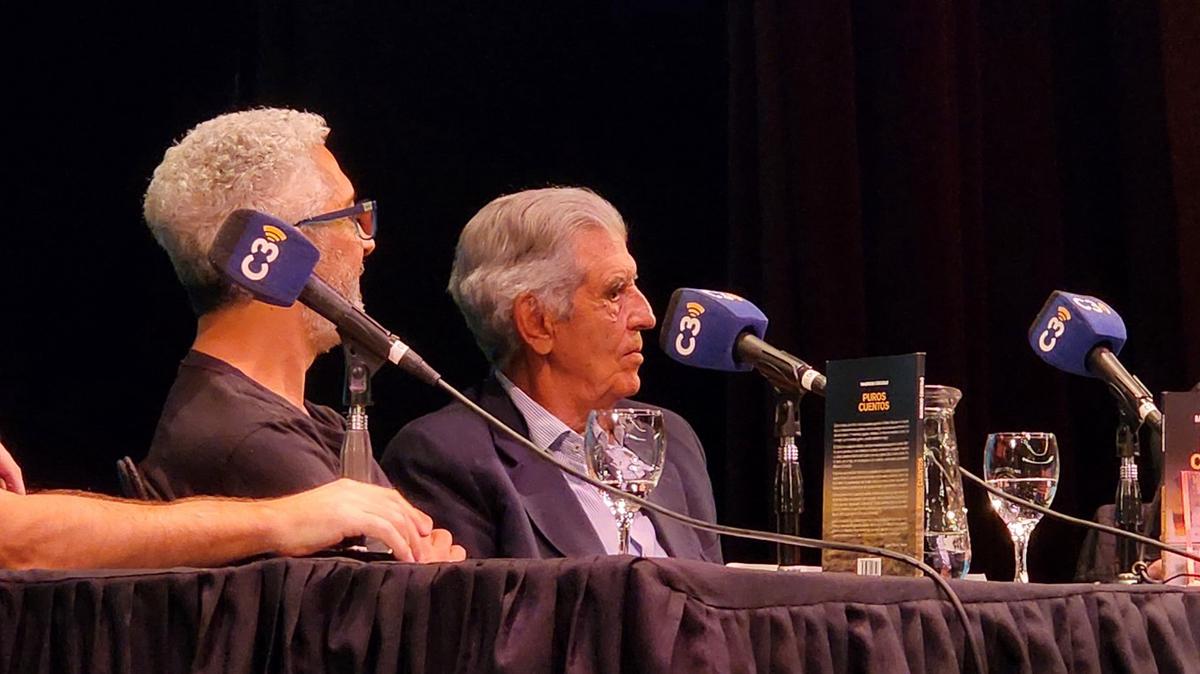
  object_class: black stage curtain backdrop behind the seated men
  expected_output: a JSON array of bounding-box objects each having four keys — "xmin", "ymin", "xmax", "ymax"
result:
[{"xmin": 0, "ymin": 0, "xmax": 1200, "ymax": 580}]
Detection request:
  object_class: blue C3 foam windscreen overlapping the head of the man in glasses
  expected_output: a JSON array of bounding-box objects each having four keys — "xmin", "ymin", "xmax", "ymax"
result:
[{"xmin": 209, "ymin": 209, "xmax": 320, "ymax": 307}]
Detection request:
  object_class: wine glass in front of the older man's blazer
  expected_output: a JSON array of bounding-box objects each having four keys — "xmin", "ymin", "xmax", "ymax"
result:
[{"xmin": 583, "ymin": 408, "xmax": 667, "ymax": 554}]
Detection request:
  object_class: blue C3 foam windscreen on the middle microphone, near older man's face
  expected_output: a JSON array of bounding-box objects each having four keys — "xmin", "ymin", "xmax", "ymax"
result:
[{"xmin": 659, "ymin": 288, "xmax": 767, "ymax": 372}]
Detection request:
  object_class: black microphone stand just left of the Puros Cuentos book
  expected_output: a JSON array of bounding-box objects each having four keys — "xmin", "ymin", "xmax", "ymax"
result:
[{"xmin": 773, "ymin": 387, "xmax": 804, "ymax": 567}]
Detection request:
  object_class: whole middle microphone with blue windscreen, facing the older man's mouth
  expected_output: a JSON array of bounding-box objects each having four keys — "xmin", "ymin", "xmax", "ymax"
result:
[{"xmin": 659, "ymin": 288, "xmax": 826, "ymax": 396}]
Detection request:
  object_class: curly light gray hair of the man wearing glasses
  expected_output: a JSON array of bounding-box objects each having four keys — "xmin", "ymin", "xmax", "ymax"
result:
[{"xmin": 143, "ymin": 108, "xmax": 334, "ymax": 315}]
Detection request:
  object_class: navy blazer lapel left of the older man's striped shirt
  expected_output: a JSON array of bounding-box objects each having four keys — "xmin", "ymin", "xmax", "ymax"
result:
[{"xmin": 479, "ymin": 377, "xmax": 605, "ymax": 556}]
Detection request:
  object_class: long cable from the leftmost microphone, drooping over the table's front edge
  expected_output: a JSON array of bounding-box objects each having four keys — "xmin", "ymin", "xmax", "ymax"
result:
[{"xmin": 434, "ymin": 379, "xmax": 986, "ymax": 674}]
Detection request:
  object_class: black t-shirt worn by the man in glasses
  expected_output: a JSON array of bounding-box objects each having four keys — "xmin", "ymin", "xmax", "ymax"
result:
[{"xmin": 140, "ymin": 351, "xmax": 390, "ymax": 498}]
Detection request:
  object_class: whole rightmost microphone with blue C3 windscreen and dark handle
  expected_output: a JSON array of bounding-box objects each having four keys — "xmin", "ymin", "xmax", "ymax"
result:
[{"xmin": 1030, "ymin": 290, "xmax": 1163, "ymax": 431}]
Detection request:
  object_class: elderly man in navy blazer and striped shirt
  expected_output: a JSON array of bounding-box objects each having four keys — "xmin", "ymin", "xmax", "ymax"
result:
[{"xmin": 380, "ymin": 187, "xmax": 721, "ymax": 562}]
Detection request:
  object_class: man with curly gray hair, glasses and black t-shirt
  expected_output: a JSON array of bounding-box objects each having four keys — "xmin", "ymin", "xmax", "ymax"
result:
[{"xmin": 142, "ymin": 109, "xmax": 444, "ymax": 537}]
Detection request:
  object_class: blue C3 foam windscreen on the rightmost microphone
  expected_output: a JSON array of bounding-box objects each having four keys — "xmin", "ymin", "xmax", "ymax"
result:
[{"xmin": 1030, "ymin": 290, "xmax": 1126, "ymax": 377}]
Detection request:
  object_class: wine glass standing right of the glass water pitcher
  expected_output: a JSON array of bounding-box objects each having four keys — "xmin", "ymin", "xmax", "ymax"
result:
[{"xmin": 983, "ymin": 433, "xmax": 1058, "ymax": 583}]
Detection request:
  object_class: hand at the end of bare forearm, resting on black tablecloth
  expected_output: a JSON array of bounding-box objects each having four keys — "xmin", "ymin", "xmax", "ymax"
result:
[{"xmin": 263, "ymin": 480, "xmax": 467, "ymax": 561}]
